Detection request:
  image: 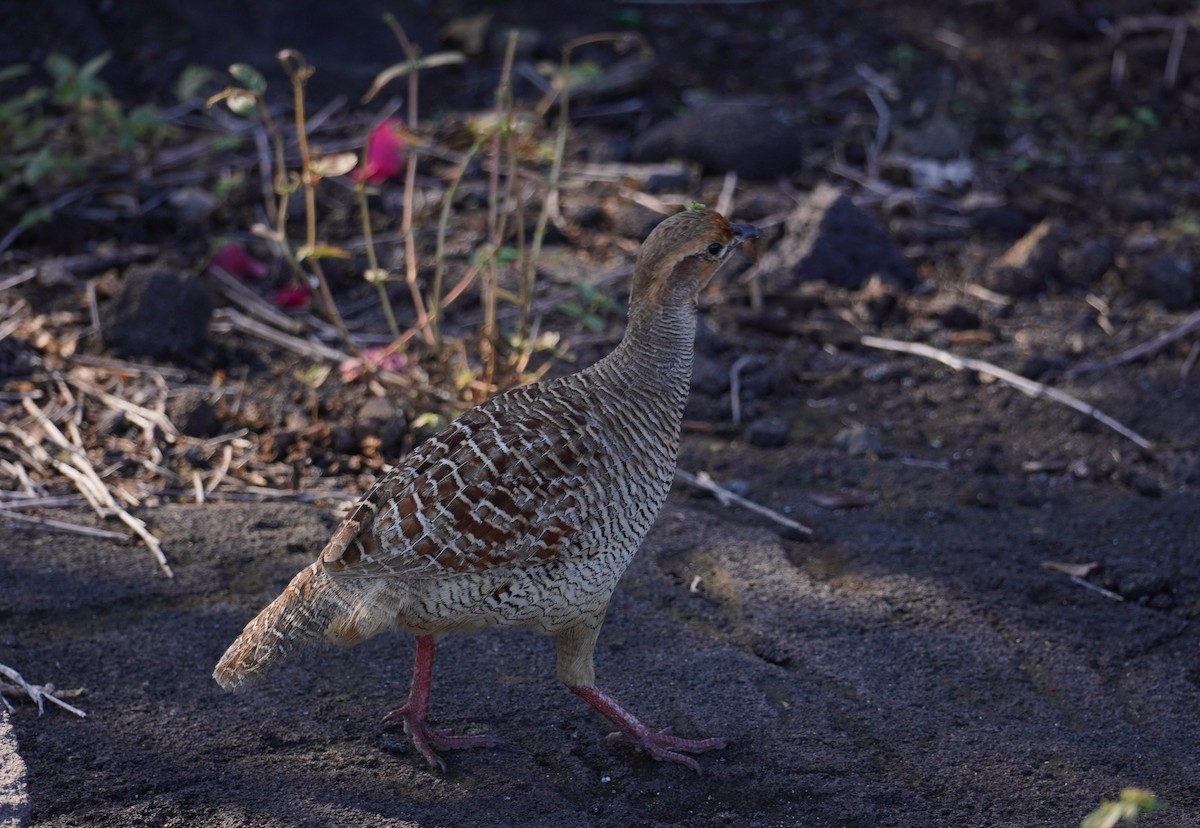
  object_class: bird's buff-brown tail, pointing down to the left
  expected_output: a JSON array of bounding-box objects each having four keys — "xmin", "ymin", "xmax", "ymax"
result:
[{"xmin": 212, "ymin": 562, "xmax": 366, "ymax": 690}]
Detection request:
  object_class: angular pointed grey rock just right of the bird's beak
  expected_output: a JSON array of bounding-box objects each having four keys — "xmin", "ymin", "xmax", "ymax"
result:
[{"xmin": 758, "ymin": 184, "xmax": 917, "ymax": 293}]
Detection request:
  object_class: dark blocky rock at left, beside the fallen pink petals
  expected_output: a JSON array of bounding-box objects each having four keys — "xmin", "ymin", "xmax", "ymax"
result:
[{"xmin": 100, "ymin": 268, "xmax": 212, "ymax": 356}]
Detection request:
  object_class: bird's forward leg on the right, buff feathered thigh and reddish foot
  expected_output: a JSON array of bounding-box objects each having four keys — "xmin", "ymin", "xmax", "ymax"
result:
[{"xmin": 554, "ymin": 616, "xmax": 725, "ymax": 773}]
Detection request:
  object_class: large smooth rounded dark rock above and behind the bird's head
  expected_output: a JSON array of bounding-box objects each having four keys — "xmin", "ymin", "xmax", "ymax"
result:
[{"xmin": 634, "ymin": 101, "xmax": 804, "ymax": 179}]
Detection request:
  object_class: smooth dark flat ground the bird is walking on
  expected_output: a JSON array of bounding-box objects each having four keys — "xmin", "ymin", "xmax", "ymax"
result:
[{"xmin": 0, "ymin": 422, "xmax": 1200, "ymax": 827}]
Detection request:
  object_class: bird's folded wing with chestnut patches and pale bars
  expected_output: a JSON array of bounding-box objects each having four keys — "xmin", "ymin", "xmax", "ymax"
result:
[{"xmin": 322, "ymin": 385, "xmax": 606, "ymax": 577}]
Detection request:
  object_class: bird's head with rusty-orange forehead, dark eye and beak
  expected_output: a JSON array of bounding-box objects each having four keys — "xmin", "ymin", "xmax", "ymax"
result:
[{"xmin": 630, "ymin": 209, "xmax": 760, "ymax": 307}]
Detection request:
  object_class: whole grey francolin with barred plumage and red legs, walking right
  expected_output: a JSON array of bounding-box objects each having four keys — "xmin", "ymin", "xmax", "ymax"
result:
[{"xmin": 214, "ymin": 210, "xmax": 758, "ymax": 770}]
